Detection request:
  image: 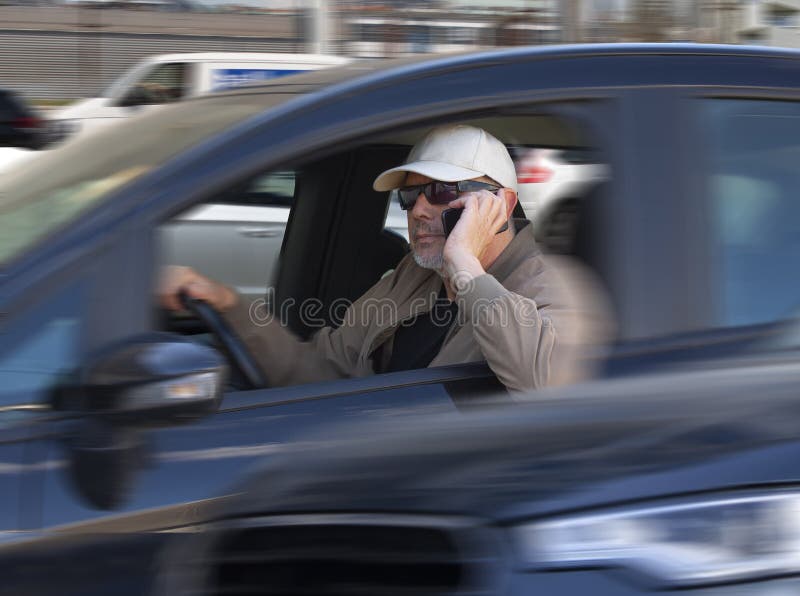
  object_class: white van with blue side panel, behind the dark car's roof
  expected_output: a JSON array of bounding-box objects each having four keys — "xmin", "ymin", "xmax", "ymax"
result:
[{"xmin": 50, "ymin": 52, "xmax": 349, "ymax": 139}]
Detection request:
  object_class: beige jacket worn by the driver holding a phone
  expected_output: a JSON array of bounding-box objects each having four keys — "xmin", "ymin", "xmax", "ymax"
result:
[{"xmin": 225, "ymin": 220, "xmax": 607, "ymax": 391}]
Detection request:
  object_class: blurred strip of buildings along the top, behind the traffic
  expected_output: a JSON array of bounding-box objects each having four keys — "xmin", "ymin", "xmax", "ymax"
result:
[{"xmin": 0, "ymin": 0, "xmax": 800, "ymax": 99}]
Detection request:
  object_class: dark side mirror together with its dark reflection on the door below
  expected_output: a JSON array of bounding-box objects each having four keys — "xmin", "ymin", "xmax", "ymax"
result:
[{"xmin": 52, "ymin": 333, "xmax": 226, "ymax": 509}]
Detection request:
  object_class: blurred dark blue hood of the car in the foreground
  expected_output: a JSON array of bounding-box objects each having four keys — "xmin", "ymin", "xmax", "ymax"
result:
[{"xmin": 222, "ymin": 364, "xmax": 800, "ymax": 521}]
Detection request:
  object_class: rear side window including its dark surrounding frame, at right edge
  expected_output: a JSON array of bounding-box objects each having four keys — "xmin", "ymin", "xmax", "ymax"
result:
[{"xmin": 686, "ymin": 88, "xmax": 800, "ymax": 359}]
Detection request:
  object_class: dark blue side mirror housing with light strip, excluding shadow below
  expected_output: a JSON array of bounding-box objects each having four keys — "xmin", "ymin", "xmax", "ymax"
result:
[{"xmin": 53, "ymin": 333, "xmax": 226, "ymax": 427}]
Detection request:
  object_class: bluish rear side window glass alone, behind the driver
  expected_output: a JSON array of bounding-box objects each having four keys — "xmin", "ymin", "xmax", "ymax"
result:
[{"xmin": 703, "ymin": 100, "xmax": 800, "ymax": 326}]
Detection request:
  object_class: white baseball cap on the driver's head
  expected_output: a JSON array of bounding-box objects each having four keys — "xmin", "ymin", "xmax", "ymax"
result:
[{"xmin": 372, "ymin": 124, "xmax": 517, "ymax": 192}]
